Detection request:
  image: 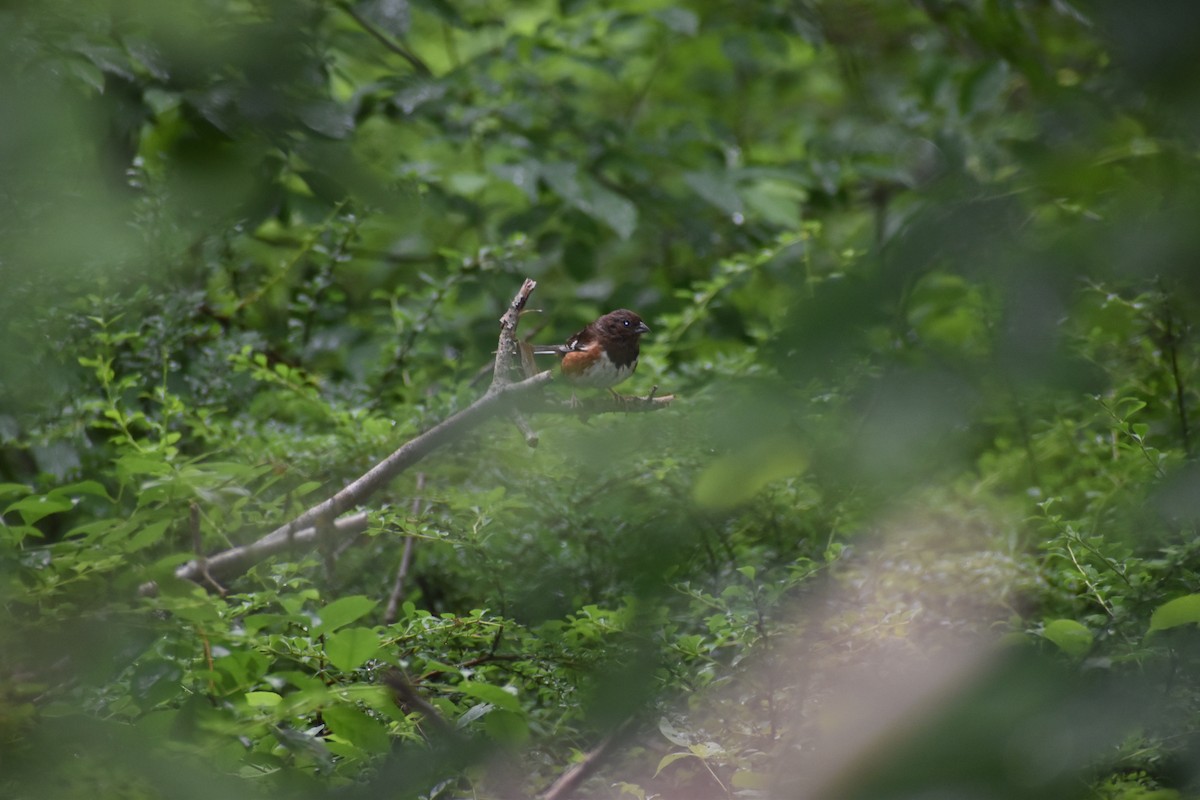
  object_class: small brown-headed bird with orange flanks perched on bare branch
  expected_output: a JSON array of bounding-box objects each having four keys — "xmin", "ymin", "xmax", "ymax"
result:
[{"xmin": 532, "ymin": 308, "xmax": 650, "ymax": 397}]
